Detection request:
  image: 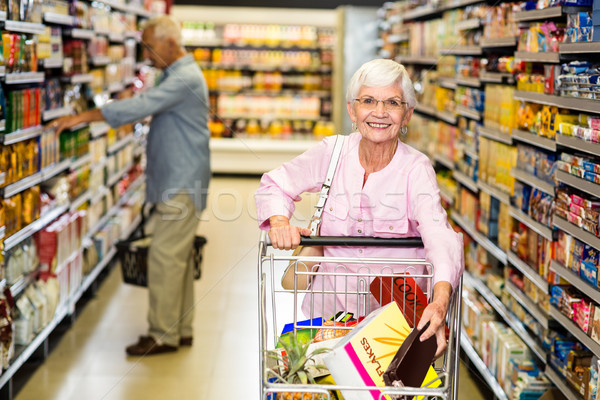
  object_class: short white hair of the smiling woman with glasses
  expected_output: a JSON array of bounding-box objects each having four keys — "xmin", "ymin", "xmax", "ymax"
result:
[{"xmin": 346, "ymin": 58, "xmax": 417, "ymax": 108}]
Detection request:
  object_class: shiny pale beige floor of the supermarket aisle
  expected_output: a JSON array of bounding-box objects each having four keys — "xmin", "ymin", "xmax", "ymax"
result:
[{"xmin": 16, "ymin": 177, "xmax": 484, "ymax": 400}]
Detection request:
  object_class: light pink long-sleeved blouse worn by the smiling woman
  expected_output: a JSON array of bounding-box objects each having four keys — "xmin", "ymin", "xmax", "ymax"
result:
[{"xmin": 255, "ymin": 132, "xmax": 464, "ymax": 319}]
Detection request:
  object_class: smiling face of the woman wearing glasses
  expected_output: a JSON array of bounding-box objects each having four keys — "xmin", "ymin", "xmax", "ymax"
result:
[{"xmin": 346, "ymin": 83, "xmax": 413, "ymax": 144}]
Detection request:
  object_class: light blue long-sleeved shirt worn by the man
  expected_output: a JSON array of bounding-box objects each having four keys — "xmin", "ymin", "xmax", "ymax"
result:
[{"xmin": 101, "ymin": 54, "xmax": 211, "ymax": 210}]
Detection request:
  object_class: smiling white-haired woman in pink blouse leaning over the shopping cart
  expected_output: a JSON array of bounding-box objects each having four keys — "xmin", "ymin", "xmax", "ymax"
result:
[{"xmin": 255, "ymin": 59, "xmax": 464, "ymax": 355}]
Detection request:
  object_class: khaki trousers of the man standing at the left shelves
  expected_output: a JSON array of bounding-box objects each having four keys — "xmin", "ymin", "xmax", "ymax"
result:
[{"xmin": 148, "ymin": 192, "xmax": 198, "ymax": 347}]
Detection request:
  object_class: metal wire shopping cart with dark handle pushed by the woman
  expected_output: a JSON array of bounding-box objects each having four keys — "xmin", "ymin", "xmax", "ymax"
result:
[{"xmin": 258, "ymin": 232, "xmax": 462, "ymax": 400}]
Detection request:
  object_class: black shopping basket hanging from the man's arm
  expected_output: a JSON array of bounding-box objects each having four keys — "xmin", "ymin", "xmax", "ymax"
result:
[{"xmin": 115, "ymin": 207, "xmax": 206, "ymax": 287}]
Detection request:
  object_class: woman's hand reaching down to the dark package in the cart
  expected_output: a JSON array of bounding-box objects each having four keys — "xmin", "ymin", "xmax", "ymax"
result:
[{"xmin": 417, "ymin": 281, "xmax": 452, "ymax": 358}]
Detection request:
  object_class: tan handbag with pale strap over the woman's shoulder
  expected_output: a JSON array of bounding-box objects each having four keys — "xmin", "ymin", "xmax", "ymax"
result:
[{"xmin": 281, "ymin": 135, "xmax": 346, "ymax": 290}]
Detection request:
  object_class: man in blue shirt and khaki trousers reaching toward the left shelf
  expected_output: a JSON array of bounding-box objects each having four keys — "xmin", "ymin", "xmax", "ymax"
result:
[{"xmin": 51, "ymin": 16, "xmax": 210, "ymax": 356}]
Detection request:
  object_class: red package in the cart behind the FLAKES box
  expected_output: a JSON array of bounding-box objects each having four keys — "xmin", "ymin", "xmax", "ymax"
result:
[{"xmin": 369, "ymin": 274, "xmax": 428, "ymax": 328}]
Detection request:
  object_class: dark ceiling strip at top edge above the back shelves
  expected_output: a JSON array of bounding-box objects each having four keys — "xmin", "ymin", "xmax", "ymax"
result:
[{"xmin": 174, "ymin": 0, "xmax": 382, "ymax": 9}]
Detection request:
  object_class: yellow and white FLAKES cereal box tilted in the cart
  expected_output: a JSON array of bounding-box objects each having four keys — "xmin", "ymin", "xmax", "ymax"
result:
[{"xmin": 323, "ymin": 302, "xmax": 440, "ymax": 400}]
